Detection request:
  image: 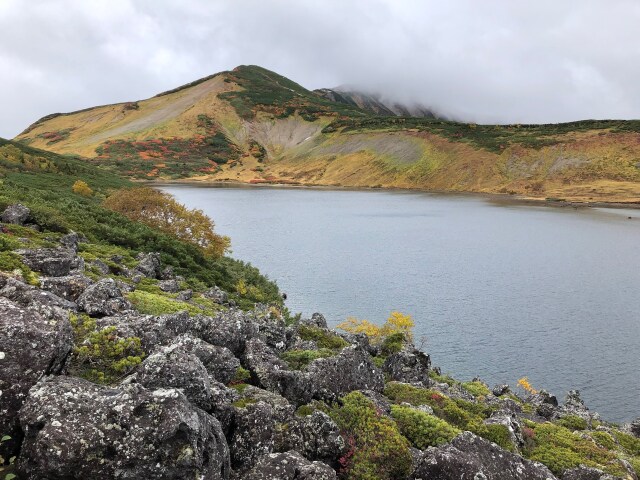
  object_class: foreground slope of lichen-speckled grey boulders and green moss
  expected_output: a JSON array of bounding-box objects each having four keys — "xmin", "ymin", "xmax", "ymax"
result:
[{"xmin": 0, "ymin": 205, "xmax": 640, "ymax": 480}]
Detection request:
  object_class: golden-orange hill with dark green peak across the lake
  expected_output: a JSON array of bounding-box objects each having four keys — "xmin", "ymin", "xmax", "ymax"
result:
[{"xmin": 16, "ymin": 66, "xmax": 640, "ymax": 202}]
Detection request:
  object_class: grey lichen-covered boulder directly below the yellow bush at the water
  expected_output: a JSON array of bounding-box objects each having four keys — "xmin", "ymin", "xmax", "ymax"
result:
[{"xmin": 306, "ymin": 345, "xmax": 384, "ymax": 401}]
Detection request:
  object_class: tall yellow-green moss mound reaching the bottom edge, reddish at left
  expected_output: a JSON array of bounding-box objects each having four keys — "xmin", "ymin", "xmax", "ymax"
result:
[{"xmin": 330, "ymin": 392, "xmax": 412, "ymax": 480}]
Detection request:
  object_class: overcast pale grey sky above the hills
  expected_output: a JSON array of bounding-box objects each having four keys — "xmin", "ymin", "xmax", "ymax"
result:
[{"xmin": 0, "ymin": 0, "xmax": 640, "ymax": 137}]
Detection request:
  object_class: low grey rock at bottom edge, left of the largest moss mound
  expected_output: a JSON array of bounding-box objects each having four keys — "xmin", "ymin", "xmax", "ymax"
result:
[{"xmin": 237, "ymin": 451, "xmax": 337, "ymax": 480}]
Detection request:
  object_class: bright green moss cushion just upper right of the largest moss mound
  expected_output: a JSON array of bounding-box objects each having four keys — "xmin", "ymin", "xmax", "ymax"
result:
[{"xmin": 391, "ymin": 405, "xmax": 460, "ymax": 450}]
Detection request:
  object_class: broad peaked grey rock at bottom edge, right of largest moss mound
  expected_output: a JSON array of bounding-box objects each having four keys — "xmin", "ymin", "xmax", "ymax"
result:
[{"xmin": 411, "ymin": 432, "xmax": 556, "ymax": 480}]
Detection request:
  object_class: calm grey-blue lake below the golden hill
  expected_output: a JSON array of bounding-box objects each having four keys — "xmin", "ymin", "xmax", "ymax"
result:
[{"xmin": 163, "ymin": 185, "xmax": 640, "ymax": 422}]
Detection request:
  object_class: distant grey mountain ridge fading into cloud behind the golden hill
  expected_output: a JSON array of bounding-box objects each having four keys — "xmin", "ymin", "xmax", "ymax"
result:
[{"xmin": 314, "ymin": 87, "xmax": 442, "ymax": 118}]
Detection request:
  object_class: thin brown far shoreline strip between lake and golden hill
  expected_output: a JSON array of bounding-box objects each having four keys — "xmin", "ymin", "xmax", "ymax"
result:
[{"xmin": 141, "ymin": 179, "xmax": 640, "ymax": 210}]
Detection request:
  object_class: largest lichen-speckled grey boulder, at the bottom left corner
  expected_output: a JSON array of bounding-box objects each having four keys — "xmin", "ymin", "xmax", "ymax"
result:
[{"xmin": 19, "ymin": 377, "xmax": 229, "ymax": 480}]
